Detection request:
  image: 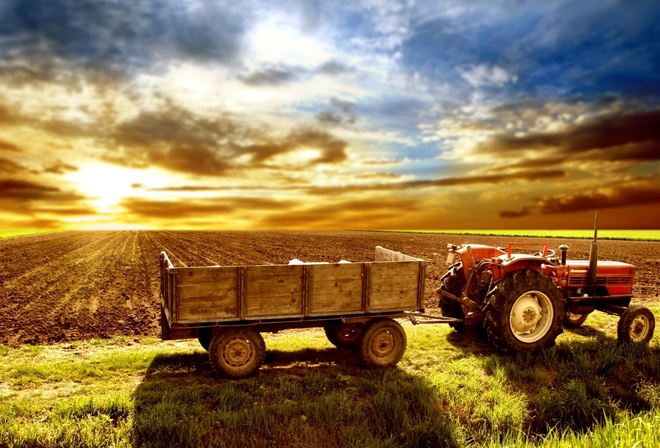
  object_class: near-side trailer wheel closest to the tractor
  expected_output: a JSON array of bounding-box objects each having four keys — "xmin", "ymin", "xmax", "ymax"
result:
[{"xmin": 360, "ymin": 318, "xmax": 407, "ymax": 369}]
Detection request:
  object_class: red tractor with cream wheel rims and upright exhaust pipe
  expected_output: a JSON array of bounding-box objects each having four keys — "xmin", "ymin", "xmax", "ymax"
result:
[{"xmin": 438, "ymin": 218, "xmax": 655, "ymax": 352}]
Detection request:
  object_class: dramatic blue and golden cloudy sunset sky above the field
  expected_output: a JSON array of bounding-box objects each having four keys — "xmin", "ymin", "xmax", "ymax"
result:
[{"xmin": 0, "ymin": 0, "xmax": 660, "ymax": 230}]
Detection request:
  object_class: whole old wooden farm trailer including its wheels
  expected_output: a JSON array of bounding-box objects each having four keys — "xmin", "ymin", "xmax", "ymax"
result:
[{"xmin": 160, "ymin": 246, "xmax": 428, "ymax": 378}]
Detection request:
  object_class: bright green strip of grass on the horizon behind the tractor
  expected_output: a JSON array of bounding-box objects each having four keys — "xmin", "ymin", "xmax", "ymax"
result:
[{"xmin": 378, "ymin": 230, "xmax": 660, "ymax": 241}]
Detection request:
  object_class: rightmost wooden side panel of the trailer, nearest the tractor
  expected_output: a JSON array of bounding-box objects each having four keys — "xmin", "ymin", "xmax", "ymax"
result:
[{"xmin": 369, "ymin": 262, "xmax": 420, "ymax": 311}]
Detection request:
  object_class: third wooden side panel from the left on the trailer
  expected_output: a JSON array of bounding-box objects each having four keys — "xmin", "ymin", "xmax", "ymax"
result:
[{"xmin": 307, "ymin": 263, "xmax": 363, "ymax": 315}]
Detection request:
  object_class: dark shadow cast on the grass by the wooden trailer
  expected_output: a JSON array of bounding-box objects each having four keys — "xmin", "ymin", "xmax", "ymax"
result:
[{"xmin": 132, "ymin": 348, "xmax": 458, "ymax": 447}]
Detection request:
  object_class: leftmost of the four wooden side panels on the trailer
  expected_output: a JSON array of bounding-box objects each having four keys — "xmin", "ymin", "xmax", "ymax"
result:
[{"xmin": 177, "ymin": 267, "xmax": 239, "ymax": 322}]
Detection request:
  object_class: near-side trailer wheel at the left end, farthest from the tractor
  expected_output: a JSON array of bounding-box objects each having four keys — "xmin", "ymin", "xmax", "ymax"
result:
[{"xmin": 209, "ymin": 328, "xmax": 266, "ymax": 379}]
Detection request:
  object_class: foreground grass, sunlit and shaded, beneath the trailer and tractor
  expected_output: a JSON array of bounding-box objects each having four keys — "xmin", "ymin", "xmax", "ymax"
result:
[{"xmin": 0, "ymin": 316, "xmax": 660, "ymax": 448}]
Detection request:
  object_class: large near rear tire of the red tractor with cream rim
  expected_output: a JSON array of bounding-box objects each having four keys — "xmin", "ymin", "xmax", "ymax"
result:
[{"xmin": 484, "ymin": 269, "xmax": 564, "ymax": 353}]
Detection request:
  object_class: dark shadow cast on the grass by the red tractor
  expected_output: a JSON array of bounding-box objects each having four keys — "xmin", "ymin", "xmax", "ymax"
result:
[{"xmin": 440, "ymin": 325, "xmax": 660, "ymax": 436}]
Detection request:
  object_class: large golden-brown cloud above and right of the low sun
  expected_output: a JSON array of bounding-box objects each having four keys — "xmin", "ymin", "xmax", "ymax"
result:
[{"xmin": 104, "ymin": 104, "xmax": 348, "ymax": 175}]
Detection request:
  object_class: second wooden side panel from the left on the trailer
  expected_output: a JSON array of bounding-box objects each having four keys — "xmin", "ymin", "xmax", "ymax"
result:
[{"xmin": 245, "ymin": 265, "xmax": 303, "ymax": 319}]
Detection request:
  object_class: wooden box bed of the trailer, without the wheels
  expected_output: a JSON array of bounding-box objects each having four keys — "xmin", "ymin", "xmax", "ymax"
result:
[{"xmin": 160, "ymin": 246, "xmax": 428, "ymax": 339}]
